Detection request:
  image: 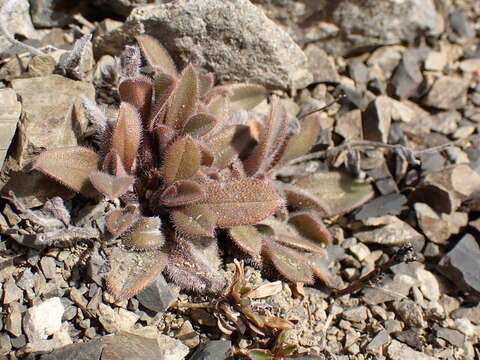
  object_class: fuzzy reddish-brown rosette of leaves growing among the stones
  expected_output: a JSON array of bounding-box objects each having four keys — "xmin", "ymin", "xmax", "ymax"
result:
[{"xmin": 33, "ymin": 36, "xmax": 371, "ymax": 299}]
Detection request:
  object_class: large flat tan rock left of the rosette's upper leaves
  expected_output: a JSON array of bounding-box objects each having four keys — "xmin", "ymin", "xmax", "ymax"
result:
[{"xmin": 12, "ymin": 75, "xmax": 95, "ymax": 168}]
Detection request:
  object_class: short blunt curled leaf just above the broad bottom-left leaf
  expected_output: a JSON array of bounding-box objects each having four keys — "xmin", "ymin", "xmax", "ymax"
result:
[{"xmin": 123, "ymin": 217, "xmax": 165, "ymax": 250}]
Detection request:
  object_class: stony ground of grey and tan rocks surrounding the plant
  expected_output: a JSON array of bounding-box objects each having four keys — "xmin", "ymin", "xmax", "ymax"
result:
[{"xmin": 0, "ymin": 0, "xmax": 480, "ymax": 360}]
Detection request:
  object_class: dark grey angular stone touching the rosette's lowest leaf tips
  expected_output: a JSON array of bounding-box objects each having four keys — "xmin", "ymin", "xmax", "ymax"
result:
[{"xmin": 137, "ymin": 275, "xmax": 178, "ymax": 312}]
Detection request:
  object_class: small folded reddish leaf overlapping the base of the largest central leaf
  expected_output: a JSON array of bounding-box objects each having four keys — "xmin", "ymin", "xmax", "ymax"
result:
[{"xmin": 160, "ymin": 180, "xmax": 205, "ymax": 206}]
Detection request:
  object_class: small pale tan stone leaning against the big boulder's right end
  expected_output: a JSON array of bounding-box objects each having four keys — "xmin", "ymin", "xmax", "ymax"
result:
[{"xmin": 305, "ymin": 44, "xmax": 340, "ymax": 83}]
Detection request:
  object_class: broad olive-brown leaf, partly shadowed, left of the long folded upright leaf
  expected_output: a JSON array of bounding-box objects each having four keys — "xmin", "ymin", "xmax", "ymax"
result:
[{"xmin": 206, "ymin": 125, "xmax": 254, "ymax": 170}]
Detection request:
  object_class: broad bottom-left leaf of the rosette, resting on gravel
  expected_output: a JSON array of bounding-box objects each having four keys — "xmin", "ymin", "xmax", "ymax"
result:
[{"xmin": 107, "ymin": 247, "xmax": 167, "ymax": 300}]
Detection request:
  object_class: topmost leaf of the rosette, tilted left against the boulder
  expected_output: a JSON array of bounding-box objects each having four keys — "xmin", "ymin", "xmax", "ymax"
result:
[{"xmin": 136, "ymin": 35, "xmax": 177, "ymax": 77}]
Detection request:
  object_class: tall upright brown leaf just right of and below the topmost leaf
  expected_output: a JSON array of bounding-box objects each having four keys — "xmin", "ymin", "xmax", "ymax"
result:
[{"xmin": 165, "ymin": 65, "xmax": 199, "ymax": 130}]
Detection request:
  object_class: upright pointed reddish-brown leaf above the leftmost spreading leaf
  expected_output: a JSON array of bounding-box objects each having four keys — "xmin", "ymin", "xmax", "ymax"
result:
[{"xmin": 112, "ymin": 103, "xmax": 142, "ymax": 173}]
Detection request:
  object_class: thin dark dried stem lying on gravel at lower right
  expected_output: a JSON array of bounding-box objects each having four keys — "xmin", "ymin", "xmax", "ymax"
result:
[{"xmin": 333, "ymin": 243, "xmax": 416, "ymax": 297}]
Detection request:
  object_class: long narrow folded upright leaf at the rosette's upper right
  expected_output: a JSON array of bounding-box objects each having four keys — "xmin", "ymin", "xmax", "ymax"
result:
[{"xmin": 245, "ymin": 96, "xmax": 287, "ymax": 176}]
